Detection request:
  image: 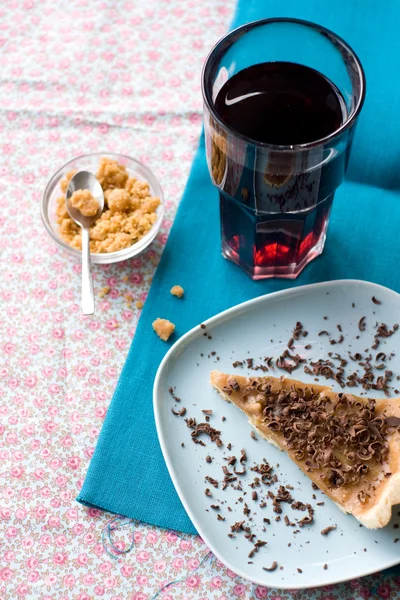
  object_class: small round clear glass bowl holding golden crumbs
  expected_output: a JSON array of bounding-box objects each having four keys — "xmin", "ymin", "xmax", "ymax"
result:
[{"xmin": 41, "ymin": 152, "xmax": 164, "ymax": 265}]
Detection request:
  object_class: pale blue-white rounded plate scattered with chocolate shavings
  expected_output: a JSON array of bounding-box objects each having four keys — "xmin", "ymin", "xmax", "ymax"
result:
[{"xmin": 154, "ymin": 281, "xmax": 400, "ymax": 589}]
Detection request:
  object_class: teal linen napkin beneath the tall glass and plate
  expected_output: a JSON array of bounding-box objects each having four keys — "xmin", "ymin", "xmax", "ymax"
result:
[{"xmin": 78, "ymin": 0, "xmax": 400, "ymax": 533}]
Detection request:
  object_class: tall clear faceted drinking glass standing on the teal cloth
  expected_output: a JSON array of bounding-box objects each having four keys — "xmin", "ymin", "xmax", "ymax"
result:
[{"xmin": 202, "ymin": 18, "xmax": 365, "ymax": 279}]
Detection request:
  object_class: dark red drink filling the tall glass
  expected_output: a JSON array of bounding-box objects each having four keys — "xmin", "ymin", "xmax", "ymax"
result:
[{"xmin": 211, "ymin": 62, "xmax": 348, "ymax": 278}]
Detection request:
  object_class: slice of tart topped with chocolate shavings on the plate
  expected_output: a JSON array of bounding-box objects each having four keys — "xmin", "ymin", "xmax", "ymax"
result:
[{"xmin": 211, "ymin": 371, "xmax": 400, "ymax": 529}]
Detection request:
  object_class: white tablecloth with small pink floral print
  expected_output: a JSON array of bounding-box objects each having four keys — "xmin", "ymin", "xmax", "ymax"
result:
[{"xmin": 0, "ymin": 0, "xmax": 400, "ymax": 600}]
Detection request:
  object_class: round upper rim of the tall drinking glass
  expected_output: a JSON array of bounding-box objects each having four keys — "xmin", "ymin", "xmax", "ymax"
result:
[{"xmin": 201, "ymin": 17, "xmax": 366, "ymax": 152}]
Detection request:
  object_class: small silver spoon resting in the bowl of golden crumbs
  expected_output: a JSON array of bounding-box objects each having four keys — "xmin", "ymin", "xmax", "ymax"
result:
[{"xmin": 65, "ymin": 171, "xmax": 104, "ymax": 315}]
